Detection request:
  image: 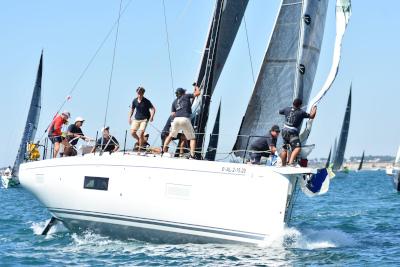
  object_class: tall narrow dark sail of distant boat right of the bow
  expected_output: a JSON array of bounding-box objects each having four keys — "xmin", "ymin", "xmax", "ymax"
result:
[{"xmin": 332, "ymin": 85, "xmax": 351, "ymax": 170}]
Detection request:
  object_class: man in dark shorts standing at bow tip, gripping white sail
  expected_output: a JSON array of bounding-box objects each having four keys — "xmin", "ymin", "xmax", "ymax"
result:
[{"xmin": 279, "ymin": 98, "xmax": 317, "ymax": 166}]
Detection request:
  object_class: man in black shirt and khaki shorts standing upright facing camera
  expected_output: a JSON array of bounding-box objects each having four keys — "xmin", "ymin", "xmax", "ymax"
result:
[{"xmin": 128, "ymin": 87, "xmax": 156, "ymax": 151}]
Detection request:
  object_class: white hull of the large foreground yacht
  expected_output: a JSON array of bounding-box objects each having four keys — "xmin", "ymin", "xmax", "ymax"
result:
[{"xmin": 19, "ymin": 153, "xmax": 313, "ymax": 246}]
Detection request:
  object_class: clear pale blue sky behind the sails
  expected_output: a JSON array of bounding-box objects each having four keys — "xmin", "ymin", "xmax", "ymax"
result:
[{"xmin": 0, "ymin": 0, "xmax": 400, "ymax": 166}]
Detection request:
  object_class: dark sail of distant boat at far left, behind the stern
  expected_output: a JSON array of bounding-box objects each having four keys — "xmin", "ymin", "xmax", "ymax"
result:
[{"xmin": 12, "ymin": 51, "xmax": 43, "ymax": 177}]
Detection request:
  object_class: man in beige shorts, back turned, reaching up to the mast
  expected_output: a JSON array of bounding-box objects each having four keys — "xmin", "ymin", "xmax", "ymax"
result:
[{"xmin": 163, "ymin": 86, "xmax": 200, "ymax": 158}]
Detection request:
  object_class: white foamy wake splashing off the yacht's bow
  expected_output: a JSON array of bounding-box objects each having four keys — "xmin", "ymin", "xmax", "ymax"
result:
[{"xmin": 283, "ymin": 228, "xmax": 356, "ymax": 250}]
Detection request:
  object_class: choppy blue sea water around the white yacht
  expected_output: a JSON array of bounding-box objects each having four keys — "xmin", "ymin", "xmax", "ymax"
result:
[{"xmin": 0, "ymin": 171, "xmax": 400, "ymax": 266}]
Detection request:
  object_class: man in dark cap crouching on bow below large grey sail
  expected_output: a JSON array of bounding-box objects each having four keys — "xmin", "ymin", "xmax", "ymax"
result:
[{"xmin": 249, "ymin": 125, "xmax": 281, "ymax": 164}]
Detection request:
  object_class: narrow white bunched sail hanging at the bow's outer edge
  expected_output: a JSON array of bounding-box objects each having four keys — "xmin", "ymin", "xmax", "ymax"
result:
[{"xmin": 300, "ymin": 0, "xmax": 351, "ymax": 144}]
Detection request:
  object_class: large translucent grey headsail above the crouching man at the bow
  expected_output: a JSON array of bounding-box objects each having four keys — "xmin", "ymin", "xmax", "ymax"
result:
[{"xmin": 233, "ymin": 0, "xmax": 328, "ymax": 156}]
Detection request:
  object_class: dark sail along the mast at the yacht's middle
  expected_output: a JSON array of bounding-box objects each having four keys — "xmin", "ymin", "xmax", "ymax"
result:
[{"xmin": 192, "ymin": 0, "xmax": 248, "ymax": 157}]
